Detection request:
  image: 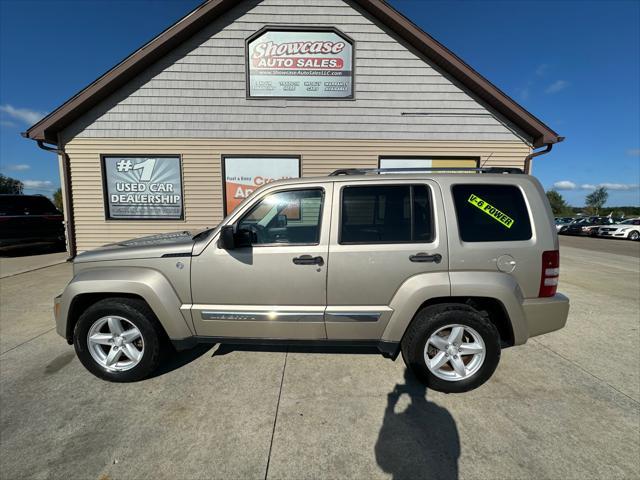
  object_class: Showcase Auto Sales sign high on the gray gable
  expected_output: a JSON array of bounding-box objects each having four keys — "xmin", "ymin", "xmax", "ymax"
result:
[{"xmin": 247, "ymin": 30, "xmax": 353, "ymax": 98}]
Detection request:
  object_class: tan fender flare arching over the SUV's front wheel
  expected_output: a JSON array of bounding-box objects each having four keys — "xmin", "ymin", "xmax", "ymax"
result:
[{"xmin": 58, "ymin": 267, "xmax": 194, "ymax": 339}]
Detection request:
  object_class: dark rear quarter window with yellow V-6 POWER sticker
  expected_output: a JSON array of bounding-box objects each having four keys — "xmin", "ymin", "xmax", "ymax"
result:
[{"xmin": 451, "ymin": 184, "xmax": 531, "ymax": 242}]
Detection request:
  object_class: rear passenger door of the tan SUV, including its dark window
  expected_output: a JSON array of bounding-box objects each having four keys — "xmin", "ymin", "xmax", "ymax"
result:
[{"xmin": 325, "ymin": 180, "xmax": 449, "ymax": 340}]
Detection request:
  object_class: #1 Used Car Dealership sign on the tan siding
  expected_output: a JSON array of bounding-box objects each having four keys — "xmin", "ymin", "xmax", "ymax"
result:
[{"xmin": 103, "ymin": 157, "xmax": 182, "ymax": 220}]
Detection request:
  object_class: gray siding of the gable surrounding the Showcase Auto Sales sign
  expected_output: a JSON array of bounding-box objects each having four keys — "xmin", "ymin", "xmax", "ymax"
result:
[{"xmin": 63, "ymin": 0, "xmax": 529, "ymax": 143}]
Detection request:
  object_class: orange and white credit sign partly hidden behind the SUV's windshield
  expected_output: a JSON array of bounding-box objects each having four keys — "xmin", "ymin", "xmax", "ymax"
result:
[{"xmin": 224, "ymin": 157, "xmax": 300, "ymax": 215}]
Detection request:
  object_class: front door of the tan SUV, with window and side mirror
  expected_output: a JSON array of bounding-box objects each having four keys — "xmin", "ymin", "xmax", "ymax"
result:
[{"xmin": 192, "ymin": 182, "xmax": 332, "ymax": 339}]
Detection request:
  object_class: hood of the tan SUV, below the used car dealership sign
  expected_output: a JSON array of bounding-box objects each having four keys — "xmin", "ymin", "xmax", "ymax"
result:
[{"xmin": 74, "ymin": 231, "xmax": 194, "ymax": 263}]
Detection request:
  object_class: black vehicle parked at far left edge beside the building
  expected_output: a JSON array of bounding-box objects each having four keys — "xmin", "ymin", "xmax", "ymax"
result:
[{"xmin": 0, "ymin": 194, "xmax": 65, "ymax": 251}]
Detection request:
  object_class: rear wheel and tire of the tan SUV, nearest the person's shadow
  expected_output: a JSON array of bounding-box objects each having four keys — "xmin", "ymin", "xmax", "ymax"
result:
[{"xmin": 401, "ymin": 304, "xmax": 500, "ymax": 393}]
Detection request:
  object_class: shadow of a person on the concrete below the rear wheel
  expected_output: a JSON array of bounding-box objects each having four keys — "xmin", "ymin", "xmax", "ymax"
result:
[{"xmin": 375, "ymin": 369, "xmax": 460, "ymax": 480}]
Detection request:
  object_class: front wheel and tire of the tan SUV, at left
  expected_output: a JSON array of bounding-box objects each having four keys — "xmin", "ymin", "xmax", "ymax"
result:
[{"xmin": 73, "ymin": 298, "xmax": 162, "ymax": 382}]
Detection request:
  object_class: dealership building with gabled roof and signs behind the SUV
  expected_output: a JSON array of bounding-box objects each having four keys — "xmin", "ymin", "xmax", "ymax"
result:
[{"xmin": 24, "ymin": 0, "xmax": 562, "ymax": 255}]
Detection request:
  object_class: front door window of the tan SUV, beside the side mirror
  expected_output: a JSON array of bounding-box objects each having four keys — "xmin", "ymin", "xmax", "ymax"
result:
[{"xmin": 237, "ymin": 188, "xmax": 324, "ymax": 245}]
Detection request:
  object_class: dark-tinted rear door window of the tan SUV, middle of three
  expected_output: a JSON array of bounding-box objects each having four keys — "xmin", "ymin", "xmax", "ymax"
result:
[{"xmin": 340, "ymin": 185, "xmax": 433, "ymax": 244}]
